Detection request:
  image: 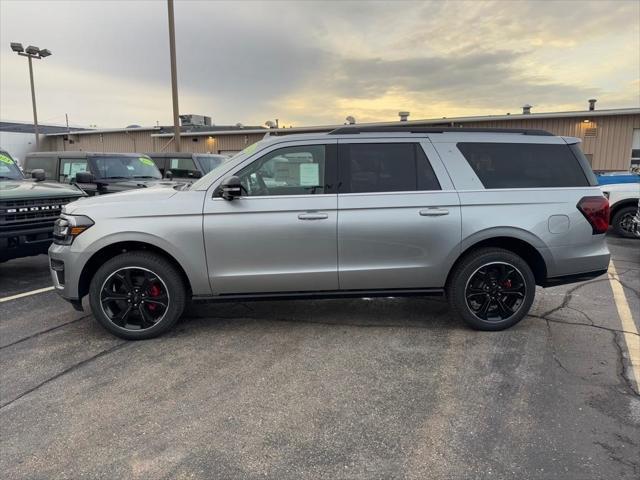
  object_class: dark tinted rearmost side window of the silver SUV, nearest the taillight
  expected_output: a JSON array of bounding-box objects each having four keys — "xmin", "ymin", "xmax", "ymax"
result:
[{"xmin": 457, "ymin": 142, "xmax": 590, "ymax": 188}]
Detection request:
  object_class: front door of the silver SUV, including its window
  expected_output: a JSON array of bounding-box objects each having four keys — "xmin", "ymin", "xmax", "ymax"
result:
[{"xmin": 203, "ymin": 140, "xmax": 338, "ymax": 294}]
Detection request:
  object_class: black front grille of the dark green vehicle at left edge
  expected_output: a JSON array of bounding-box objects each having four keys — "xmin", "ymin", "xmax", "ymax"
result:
[{"xmin": 0, "ymin": 197, "xmax": 77, "ymax": 235}]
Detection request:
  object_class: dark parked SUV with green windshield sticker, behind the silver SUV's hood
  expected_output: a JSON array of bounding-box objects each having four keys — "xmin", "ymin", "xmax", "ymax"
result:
[{"xmin": 24, "ymin": 152, "xmax": 174, "ymax": 196}]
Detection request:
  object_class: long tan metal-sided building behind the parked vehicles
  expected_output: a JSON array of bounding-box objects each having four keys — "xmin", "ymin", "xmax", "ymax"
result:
[{"xmin": 33, "ymin": 101, "xmax": 640, "ymax": 171}]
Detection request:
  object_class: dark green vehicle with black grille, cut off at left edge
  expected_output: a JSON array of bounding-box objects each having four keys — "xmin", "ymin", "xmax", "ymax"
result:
[{"xmin": 0, "ymin": 150, "xmax": 85, "ymax": 262}]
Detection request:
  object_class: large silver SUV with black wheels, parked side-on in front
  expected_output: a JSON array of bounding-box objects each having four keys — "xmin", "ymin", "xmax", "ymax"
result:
[{"xmin": 49, "ymin": 126, "xmax": 609, "ymax": 339}]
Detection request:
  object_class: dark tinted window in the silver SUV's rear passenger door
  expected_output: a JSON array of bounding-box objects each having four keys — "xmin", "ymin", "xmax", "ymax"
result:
[{"xmin": 339, "ymin": 143, "xmax": 440, "ymax": 193}]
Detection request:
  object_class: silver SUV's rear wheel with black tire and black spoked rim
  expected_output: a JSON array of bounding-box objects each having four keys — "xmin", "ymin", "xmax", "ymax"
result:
[{"xmin": 447, "ymin": 248, "xmax": 536, "ymax": 331}]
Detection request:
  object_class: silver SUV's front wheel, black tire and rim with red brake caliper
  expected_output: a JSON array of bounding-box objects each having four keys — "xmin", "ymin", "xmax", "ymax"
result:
[{"xmin": 89, "ymin": 251, "xmax": 186, "ymax": 340}]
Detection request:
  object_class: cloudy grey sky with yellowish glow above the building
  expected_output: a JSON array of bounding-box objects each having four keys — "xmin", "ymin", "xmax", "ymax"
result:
[{"xmin": 0, "ymin": 0, "xmax": 640, "ymax": 128}]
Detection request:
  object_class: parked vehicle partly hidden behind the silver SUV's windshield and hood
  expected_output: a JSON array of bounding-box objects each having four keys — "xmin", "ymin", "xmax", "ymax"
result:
[{"xmin": 147, "ymin": 152, "xmax": 229, "ymax": 180}]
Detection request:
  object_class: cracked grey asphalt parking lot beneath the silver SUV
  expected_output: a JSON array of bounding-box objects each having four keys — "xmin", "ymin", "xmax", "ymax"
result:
[{"xmin": 0, "ymin": 237, "xmax": 640, "ymax": 479}]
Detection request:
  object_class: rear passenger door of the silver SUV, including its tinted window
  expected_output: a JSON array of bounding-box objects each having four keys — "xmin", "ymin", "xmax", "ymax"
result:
[{"xmin": 338, "ymin": 139, "xmax": 460, "ymax": 290}]
